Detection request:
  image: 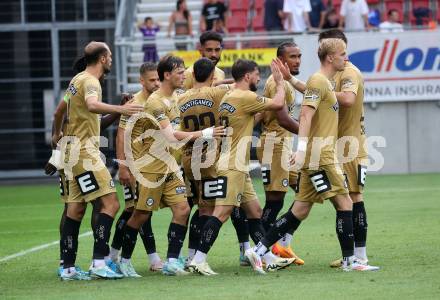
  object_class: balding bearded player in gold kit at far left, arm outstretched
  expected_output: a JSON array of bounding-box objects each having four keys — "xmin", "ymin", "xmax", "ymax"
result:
[{"xmin": 54, "ymin": 42, "xmax": 142, "ymax": 280}]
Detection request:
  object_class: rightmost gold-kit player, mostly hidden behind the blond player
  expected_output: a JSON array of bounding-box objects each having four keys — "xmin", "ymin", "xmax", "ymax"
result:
[{"xmin": 319, "ymin": 29, "xmax": 376, "ymax": 267}]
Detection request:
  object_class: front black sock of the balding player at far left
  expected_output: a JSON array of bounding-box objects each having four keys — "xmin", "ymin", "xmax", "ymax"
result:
[{"xmin": 93, "ymin": 213, "xmax": 114, "ymax": 259}]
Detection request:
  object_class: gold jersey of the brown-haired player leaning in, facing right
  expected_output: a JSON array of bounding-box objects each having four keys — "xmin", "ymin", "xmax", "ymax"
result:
[{"xmin": 131, "ymin": 90, "xmax": 177, "ymax": 174}]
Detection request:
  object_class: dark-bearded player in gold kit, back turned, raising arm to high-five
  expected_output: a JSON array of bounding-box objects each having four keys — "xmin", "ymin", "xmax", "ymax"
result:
[{"xmin": 189, "ymin": 59, "xmax": 294, "ymax": 276}]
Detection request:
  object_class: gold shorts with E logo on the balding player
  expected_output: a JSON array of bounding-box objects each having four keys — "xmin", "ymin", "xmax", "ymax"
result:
[{"xmin": 67, "ymin": 153, "xmax": 116, "ymax": 202}]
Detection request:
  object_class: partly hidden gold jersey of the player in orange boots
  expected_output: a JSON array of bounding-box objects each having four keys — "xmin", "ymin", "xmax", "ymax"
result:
[{"xmin": 261, "ymin": 75, "xmax": 295, "ymax": 144}]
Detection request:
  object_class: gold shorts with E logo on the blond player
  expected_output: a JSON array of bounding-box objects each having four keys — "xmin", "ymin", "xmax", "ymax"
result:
[{"xmin": 295, "ymin": 164, "xmax": 348, "ymax": 203}]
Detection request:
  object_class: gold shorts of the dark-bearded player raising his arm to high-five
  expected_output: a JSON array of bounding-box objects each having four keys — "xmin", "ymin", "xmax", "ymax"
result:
[{"xmin": 215, "ymin": 170, "xmax": 258, "ymax": 206}]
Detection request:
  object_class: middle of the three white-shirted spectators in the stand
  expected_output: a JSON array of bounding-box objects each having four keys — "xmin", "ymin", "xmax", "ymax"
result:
[{"xmin": 339, "ymin": 0, "xmax": 369, "ymax": 31}]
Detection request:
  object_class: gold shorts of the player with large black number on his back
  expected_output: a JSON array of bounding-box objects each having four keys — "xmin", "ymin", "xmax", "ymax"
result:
[{"xmin": 182, "ymin": 154, "xmax": 218, "ymax": 207}]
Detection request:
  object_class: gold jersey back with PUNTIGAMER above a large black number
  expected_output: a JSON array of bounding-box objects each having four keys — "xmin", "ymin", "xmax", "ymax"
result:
[{"xmin": 178, "ymin": 85, "xmax": 230, "ymax": 155}]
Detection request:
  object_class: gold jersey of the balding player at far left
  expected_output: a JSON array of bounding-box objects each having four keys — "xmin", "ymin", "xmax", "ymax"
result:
[{"xmin": 64, "ymin": 71, "xmax": 102, "ymax": 149}]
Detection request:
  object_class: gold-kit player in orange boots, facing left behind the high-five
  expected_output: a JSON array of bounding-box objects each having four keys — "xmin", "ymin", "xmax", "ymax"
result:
[{"xmin": 257, "ymin": 42, "xmax": 304, "ymax": 265}]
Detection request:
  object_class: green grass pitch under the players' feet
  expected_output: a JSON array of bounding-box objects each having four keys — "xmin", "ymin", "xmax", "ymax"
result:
[{"xmin": 0, "ymin": 174, "xmax": 440, "ymax": 300}]
